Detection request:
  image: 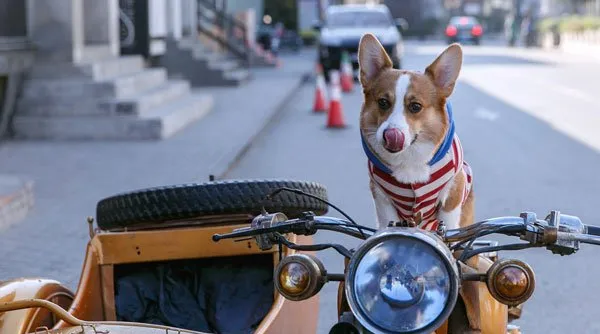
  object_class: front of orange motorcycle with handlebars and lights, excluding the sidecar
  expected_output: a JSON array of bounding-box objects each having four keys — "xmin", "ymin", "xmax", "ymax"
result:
[{"xmin": 213, "ymin": 189, "xmax": 600, "ymax": 334}]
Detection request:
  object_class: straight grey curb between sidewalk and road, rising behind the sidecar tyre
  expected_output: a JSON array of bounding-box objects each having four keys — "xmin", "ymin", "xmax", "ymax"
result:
[{"xmin": 215, "ymin": 70, "xmax": 312, "ymax": 179}]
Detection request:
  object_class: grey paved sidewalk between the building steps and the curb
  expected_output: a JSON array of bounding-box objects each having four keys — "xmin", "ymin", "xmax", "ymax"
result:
[{"xmin": 0, "ymin": 50, "xmax": 315, "ymax": 288}]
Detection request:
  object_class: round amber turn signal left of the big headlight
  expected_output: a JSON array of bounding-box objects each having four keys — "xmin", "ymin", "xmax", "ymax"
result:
[{"xmin": 274, "ymin": 254, "xmax": 327, "ymax": 301}]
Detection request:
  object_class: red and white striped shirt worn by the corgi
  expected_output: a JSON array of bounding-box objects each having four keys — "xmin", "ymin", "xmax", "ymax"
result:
[{"xmin": 369, "ymin": 135, "xmax": 473, "ymax": 231}]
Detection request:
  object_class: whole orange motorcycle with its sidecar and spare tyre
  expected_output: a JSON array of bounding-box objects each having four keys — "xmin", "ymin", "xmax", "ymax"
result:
[{"xmin": 0, "ymin": 180, "xmax": 600, "ymax": 334}]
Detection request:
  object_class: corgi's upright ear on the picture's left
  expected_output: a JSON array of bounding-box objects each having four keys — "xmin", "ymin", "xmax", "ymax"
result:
[{"xmin": 358, "ymin": 34, "xmax": 392, "ymax": 86}]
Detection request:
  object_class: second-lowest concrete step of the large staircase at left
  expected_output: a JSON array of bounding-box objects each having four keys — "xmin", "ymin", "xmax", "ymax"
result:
[{"xmin": 17, "ymin": 80, "xmax": 190, "ymax": 117}]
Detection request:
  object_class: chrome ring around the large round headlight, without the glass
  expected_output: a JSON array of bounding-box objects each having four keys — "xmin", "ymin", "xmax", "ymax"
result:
[{"xmin": 344, "ymin": 227, "xmax": 460, "ymax": 334}]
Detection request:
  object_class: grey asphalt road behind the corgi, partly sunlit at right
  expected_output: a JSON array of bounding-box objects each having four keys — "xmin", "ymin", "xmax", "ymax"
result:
[{"xmin": 228, "ymin": 43, "xmax": 600, "ymax": 333}]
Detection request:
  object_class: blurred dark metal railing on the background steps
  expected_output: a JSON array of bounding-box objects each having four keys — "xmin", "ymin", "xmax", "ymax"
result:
[{"xmin": 197, "ymin": 0, "xmax": 251, "ymax": 66}]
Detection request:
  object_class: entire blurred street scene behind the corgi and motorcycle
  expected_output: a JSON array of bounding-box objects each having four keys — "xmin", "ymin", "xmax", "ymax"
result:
[{"xmin": 0, "ymin": 0, "xmax": 600, "ymax": 333}]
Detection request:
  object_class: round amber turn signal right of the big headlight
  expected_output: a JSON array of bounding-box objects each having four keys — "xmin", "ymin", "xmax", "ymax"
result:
[{"xmin": 486, "ymin": 260, "xmax": 535, "ymax": 306}]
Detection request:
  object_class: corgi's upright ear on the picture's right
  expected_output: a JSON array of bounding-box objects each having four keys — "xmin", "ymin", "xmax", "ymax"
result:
[{"xmin": 425, "ymin": 43, "xmax": 462, "ymax": 97}]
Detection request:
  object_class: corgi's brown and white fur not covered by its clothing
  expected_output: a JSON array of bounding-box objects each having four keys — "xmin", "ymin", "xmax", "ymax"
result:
[{"xmin": 359, "ymin": 34, "xmax": 474, "ymax": 228}]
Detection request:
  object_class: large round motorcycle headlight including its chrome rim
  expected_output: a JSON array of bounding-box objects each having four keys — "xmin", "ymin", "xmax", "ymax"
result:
[{"xmin": 345, "ymin": 228, "xmax": 460, "ymax": 333}]
